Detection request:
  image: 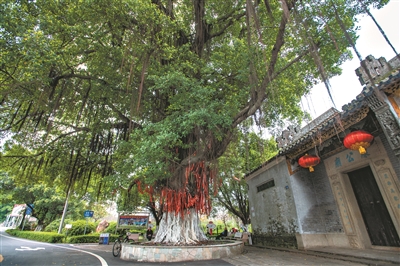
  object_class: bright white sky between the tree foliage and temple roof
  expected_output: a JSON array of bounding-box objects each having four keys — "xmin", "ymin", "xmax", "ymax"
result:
[{"xmin": 302, "ymin": 0, "xmax": 400, "ymax": 119}]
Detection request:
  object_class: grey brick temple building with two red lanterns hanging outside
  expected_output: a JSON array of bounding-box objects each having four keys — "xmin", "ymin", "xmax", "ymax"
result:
[{"xmin": 245, "ymin": 56, "xmax": 400, "ymax": 250}]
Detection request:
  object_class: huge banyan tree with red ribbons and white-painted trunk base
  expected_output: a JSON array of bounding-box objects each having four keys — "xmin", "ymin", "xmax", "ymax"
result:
[{"xmin": 0, "ymin": 0, "xmax": 387, "ymax": 244}]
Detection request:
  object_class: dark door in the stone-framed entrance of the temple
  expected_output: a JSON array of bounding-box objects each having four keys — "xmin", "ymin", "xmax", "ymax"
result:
[{"xmin": 347, "ymin": 166, "xmax": 400, "ymax": 247}]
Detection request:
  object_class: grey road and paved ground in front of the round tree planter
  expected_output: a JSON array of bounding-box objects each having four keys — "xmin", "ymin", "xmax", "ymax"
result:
[{"xmin": 0, "ymin": 228, "xmax": 374, "ymax": 266}]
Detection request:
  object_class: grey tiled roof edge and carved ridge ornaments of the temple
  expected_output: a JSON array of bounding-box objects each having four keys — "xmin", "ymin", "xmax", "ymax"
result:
[{"xmin": 277, "ymin": 55, "xmax": 400, "ymax": 159}]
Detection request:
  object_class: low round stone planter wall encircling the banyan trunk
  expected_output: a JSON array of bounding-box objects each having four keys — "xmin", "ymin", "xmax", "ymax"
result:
[{"xmin": 121, "ymin": 241, "xmax": 244, "ymax": 262}]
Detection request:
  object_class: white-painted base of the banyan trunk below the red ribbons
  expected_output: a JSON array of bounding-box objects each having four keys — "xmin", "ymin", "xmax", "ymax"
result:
[{"xmin": 154, "ymin": 208, "xmax": 208, "ymax": 245}]
